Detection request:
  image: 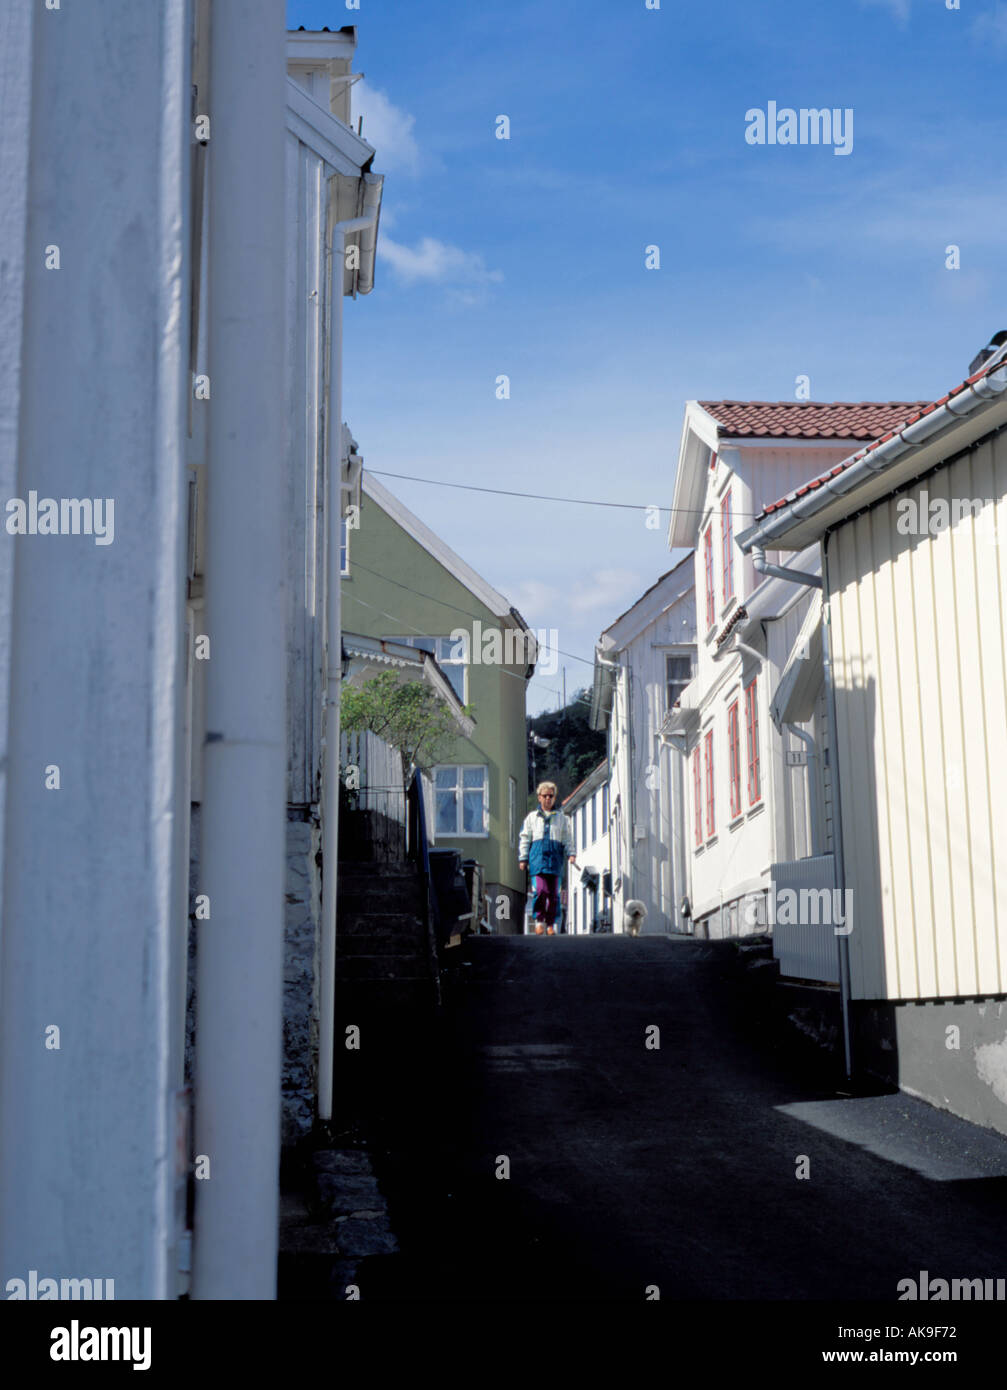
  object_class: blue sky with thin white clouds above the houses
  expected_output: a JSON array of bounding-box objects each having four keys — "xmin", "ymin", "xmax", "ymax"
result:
[{"xmin": 288, "ymin": 0, "xmax": 1007, "ymax": 713}]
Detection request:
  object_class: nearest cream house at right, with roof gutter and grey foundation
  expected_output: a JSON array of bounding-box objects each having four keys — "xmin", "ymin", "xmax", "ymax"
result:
[{"xmin": 740, "ymin": 334, "xmax": 1007, "ymax": 1133}]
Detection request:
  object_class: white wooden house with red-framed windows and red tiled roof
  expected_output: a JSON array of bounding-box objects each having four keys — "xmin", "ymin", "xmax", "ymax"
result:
[{"xmin": 662, "ymin": 400, "xmax": 912, "ymax": 937}]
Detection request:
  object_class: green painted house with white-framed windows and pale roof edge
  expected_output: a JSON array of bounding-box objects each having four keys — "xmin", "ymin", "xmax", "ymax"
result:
[{"xmin": 342, "ymin": 473, "xmax": 537, "ymax": 934}]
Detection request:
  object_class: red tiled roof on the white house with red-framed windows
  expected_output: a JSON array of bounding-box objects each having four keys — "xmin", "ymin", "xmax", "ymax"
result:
[{"xmin": 700, "ymin": 400, "xmax": 926, "ymax": 439}]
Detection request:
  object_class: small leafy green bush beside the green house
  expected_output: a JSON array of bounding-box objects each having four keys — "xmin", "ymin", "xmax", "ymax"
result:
[{"xmin": 339, "ymin": 671, "xmax": 458, "ymax": 784}]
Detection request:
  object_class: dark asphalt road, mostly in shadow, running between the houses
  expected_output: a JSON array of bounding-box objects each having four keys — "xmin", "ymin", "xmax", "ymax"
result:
[{"xmin": 360, "ymin": 935, "xmax": 1007, "ymax": 1302}]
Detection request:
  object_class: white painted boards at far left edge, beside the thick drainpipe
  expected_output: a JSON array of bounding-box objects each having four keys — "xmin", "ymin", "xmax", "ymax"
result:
[{"xmin": 0, "ymin": 0, "xmax": 192, "ymax": 1298}]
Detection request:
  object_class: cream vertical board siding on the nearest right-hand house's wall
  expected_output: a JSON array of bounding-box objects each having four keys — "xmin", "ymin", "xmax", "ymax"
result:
[{"xmin": 828, "ymin": 436, "xmax": 1007, "ymax": 999}]
